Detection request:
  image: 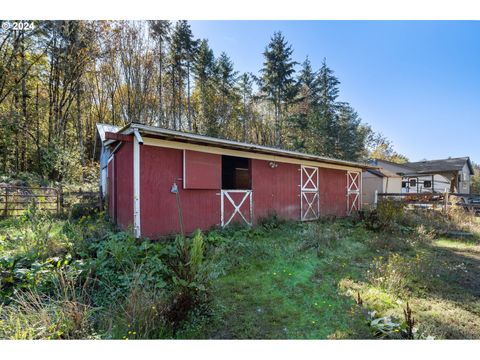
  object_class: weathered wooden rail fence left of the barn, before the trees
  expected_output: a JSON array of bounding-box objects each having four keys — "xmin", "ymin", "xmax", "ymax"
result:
[{"xmin": 0, "ymin": 185, "xmax": 102, "ymax": 217}]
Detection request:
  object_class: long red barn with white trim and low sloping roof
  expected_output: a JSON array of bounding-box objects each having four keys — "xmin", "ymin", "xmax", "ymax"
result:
[{"xmin": 97, "ymin": 123, "xmax": 374, "ymax": 238}]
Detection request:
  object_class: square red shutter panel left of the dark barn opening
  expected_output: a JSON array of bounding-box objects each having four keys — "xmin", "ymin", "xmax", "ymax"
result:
[{"xmin": 183, "ymin": 150, "xmax": 222, "ymax": 190}]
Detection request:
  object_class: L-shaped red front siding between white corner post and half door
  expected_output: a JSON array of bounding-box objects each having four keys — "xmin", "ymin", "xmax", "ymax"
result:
[{"xmin": 140, "ymin": 145, "xmax": 220, "ymax": 238}]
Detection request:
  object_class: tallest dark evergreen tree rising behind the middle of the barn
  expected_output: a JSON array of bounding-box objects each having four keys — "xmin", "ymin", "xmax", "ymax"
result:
[{"xmin": 260, "ymin": 32, "xmax": 297, "ymax": 146}]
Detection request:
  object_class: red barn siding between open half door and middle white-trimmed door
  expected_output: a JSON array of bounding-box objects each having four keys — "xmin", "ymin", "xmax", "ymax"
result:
[{"xmin": 252, "ymin": 159, "xmax": 300, "ymax": 220}]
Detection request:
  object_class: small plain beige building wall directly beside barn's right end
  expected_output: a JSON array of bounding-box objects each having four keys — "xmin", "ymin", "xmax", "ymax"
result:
[{"xmin": 362, "ymin": 169, "xmax": 402, "ymax": 204}]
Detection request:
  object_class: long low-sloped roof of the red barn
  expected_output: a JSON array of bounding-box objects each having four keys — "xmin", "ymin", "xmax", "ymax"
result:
[{"xmin": 101, "ymin": 123, "xmax": 378, "ymax": 169}]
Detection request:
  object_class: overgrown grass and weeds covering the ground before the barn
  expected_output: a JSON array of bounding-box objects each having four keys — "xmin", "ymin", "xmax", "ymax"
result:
[{"xmin": 0, "ymin": 205, "xmax": 480, "ymax": 339}]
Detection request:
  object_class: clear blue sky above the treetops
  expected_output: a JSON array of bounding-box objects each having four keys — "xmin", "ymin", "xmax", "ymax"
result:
[{"xmin": 190, "ymin": 20, "xmax": 480, "ymax": 163}]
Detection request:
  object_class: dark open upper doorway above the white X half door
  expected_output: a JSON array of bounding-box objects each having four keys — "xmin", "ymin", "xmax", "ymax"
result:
[{"xmin": 222, "ymin": 155, "xmax": 252, "ymax": 190}]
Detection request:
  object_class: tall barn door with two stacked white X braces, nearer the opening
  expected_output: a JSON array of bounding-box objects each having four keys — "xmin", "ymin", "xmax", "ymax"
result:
[{"xmin": 300, "ymin": 165, "xmax": 320, "ymax": 221}]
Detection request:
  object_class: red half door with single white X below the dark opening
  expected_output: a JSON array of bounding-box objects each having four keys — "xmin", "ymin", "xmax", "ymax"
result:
[{"xmin": 220, "ymin": 190, "xmax": 253, "ymax": 227}]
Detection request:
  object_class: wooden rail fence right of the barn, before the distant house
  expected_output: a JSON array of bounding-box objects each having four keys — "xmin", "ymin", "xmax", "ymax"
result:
[{"xmin": 374, "ymin": 191, "xmax": 480, "ymax": 215}]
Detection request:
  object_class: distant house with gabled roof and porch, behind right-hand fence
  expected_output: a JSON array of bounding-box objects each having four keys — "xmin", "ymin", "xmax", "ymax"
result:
[{"xmin": 370, "ymin": 157, "xmax": 474, "ymax": 194}]
